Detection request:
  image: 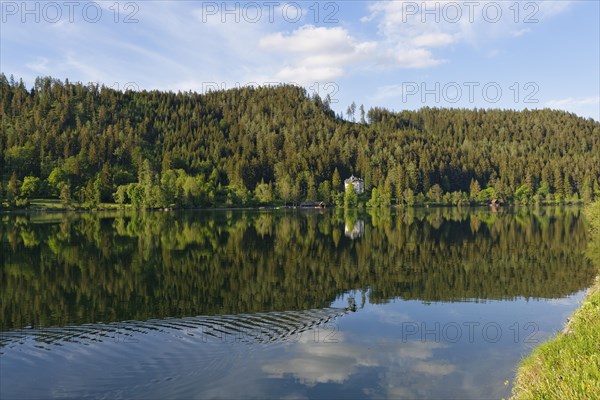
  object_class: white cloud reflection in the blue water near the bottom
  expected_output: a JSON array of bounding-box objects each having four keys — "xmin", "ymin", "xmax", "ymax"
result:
[{"xmin": 262, "ymin": 334, "xmax": 456, "ymax": 397}]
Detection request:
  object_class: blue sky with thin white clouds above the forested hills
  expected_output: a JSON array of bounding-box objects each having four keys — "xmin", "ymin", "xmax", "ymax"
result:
[{"xmin": 0, "ymin": 0, "xmax": 600, "ymax": 121}]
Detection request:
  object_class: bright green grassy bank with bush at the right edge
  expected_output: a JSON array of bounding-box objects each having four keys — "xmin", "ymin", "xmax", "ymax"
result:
[{"xmin": 513, "ymin": 201, "xmax": 600, "ymax": 399}]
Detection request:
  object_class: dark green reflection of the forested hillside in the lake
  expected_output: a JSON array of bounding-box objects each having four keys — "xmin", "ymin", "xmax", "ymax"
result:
[{"xmin": 0, "ymin": 208, "xmax": 594, "ymax": 328}]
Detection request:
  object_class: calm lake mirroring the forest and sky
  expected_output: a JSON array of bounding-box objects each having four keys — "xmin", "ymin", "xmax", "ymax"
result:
[{"xmin": 0, "ymin": 208, "xmax": 595, "ymax": 399}]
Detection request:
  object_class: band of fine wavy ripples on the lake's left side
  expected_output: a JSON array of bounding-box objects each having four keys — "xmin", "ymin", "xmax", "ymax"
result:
[{"xmin": 0, "ymin": 308, "xmax": 351, "ymax": 352}]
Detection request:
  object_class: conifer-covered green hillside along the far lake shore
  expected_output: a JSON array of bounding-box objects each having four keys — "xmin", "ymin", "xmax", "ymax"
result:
[{"xmin": 0, "ymin": 74, "xmax": 600, "ymax": 207}]
